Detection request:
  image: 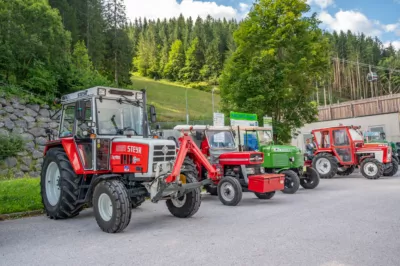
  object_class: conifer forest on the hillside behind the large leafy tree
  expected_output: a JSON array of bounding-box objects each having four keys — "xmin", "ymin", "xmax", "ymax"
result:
[{"xmin": 0, "ymin": 0, "xmax": 400, "ymax": 104}]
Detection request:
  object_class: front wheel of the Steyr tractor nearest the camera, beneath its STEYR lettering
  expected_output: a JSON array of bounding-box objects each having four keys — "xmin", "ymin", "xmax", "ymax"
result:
[{"xmin": 93, "ymin": 180, "xmax": 132, "ymax": 233}]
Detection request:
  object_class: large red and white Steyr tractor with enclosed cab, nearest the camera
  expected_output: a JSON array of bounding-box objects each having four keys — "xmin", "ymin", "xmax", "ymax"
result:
[{"xmin": 41, "ymin": 87, "xmax": 210, "ymax": 233}]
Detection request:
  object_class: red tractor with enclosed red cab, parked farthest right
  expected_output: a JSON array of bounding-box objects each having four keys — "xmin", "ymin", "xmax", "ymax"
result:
[{"xmin": 312, "ymin": 126, "xmax": 398, "ymax": 179}]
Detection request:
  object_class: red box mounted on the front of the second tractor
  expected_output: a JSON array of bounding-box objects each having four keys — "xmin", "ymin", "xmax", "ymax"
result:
[{"xmin": 248, "ymin": 174, "xmax": 285, "ymax": 193}]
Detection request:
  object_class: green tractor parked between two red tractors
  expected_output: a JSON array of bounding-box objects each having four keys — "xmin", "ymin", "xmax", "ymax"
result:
[{"xmin": 232, "ymin": 126, "xmax": 320, "ymax": 194}]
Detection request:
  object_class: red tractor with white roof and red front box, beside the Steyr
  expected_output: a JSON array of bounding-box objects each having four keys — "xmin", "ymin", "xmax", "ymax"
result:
[{"xmin": 170, "ymin": 125, "xmax": 285, "ymax": 206}]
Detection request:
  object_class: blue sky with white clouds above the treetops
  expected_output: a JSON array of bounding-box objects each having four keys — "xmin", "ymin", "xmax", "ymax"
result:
[{"xmin": 125, "ymin": 0, "xmax": 400, "ymax": 49}]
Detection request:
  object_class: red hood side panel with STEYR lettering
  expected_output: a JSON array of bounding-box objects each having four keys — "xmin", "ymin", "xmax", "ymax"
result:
[{"xmin": 110, "ymin": 142, "xmax": 149, "ymax": 173}]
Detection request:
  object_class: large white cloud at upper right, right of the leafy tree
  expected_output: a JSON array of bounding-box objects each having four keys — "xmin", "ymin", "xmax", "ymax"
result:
[{"xmin": 319, "ymin": 10, "xmax": 382, "ymax": 37}]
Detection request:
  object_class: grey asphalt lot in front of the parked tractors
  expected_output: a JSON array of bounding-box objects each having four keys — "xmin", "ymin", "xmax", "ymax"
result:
[{"xmin": 0, "ymin": 171, "xmax": 400, "ymax": 266}]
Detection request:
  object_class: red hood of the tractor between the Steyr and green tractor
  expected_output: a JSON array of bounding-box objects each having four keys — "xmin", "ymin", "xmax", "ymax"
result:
[{"xmin": 219, "ymin": 151, "xmax": 264, "ymax": 165}]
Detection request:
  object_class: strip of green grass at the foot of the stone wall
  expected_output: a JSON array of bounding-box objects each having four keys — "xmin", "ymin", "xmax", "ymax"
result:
[{"xmin": 0, "ymin": 178, "xmax": 43, "ymax": 214}]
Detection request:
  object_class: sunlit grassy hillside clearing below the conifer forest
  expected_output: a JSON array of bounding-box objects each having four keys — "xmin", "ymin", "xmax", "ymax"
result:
[{"xmin": 130, "ymin": 77, "xmax": 220, "ymax": 121}]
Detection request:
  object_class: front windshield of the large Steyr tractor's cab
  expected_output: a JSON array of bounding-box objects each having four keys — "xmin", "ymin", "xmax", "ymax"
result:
[{"xmin": 97, "ymin": 99, "xmax": 143, "ymax": 135}]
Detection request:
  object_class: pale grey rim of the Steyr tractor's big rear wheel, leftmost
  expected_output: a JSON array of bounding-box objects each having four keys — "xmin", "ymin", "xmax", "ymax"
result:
[{"xmin": 46, "ymin": 162, "xmax": 61, "ymax": 206}]
